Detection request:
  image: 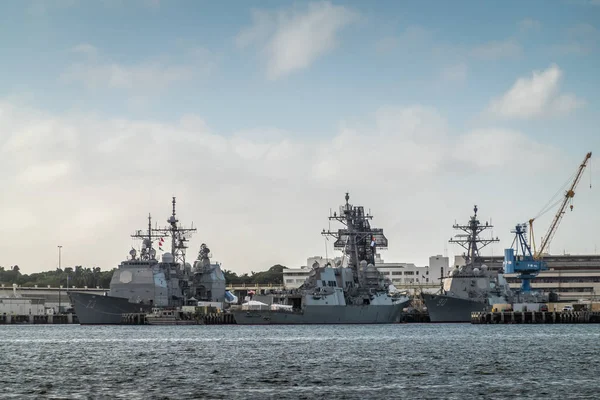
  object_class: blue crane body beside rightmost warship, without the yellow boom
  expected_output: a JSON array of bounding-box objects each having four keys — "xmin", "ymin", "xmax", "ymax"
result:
[{"xmin": 503, "ymin": 224, "xmax": 548, "ymax": 293}]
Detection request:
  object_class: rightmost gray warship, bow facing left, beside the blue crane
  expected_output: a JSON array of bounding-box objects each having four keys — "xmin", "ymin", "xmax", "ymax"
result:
[{"xmin": 421, "ymin": 206, "xmax": 512, "ymax": 322}]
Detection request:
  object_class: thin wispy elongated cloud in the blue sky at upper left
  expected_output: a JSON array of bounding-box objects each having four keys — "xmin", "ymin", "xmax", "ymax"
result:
[{"xmin": 60, "ymin": 44, "xmax": 215, "ymax": 94}]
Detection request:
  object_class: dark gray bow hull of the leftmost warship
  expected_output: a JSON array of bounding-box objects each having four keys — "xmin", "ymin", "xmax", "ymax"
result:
[{"xmin": 69, "ymin": 292, "xmax": 150, "ymax": 325}]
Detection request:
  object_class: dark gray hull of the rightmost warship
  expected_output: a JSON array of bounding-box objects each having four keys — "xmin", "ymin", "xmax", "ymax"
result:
[{"xmin": 423, "ymin": 293, "xmax": 488, "ymax": 322}]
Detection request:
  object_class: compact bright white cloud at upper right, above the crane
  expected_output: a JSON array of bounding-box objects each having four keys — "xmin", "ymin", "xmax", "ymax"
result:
[{"xmin": 488, "ymin": 64, "xmax": 585, "ymax": 118}]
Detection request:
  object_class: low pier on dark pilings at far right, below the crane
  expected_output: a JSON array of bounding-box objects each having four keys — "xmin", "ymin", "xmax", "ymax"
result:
[{"xmin": 471, "ymin": 311, "xmax": 600, "ymax": 324}]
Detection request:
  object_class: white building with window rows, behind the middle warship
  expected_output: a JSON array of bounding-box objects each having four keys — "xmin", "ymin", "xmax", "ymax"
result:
[{"xmin": 283, "ymin": 255, "xmax": 448, "ymax": 289}]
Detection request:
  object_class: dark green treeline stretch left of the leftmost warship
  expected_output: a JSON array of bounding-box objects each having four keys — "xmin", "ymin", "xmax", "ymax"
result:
[{"xmin": 0, "ymin": 265, "xmax": 113, "ymax": 288}]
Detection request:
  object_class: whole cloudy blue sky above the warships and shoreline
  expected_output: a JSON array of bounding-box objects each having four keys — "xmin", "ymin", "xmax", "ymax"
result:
[{"xmin": 0, "ymin": 0, "xmax": 600, "ymax": 273}]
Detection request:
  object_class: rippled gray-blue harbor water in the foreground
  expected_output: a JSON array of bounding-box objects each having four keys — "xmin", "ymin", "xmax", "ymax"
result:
[{"xmin": 0, "ymin": 324, "xmax": 600, "ymax": 399}]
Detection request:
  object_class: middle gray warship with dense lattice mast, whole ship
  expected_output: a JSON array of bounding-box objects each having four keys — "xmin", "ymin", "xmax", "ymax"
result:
[{"xmin": 231, "ymin": 193, "xmax": 410, "ymax": 325}]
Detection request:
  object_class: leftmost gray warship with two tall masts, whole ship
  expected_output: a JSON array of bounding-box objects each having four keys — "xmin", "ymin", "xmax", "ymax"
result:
[{"xmin": 69, "ymin": 197, "xmax": 225, "ymax": 325}]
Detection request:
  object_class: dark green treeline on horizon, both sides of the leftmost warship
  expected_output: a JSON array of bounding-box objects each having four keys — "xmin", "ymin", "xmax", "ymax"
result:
[{"xmin": 0, "ymin": 264, "xmax": 286, "ymax": 289}]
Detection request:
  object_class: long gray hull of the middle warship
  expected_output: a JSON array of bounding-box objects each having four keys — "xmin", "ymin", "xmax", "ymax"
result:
[{"xmin": 233, "ymin": 302, "xmax": 409, "ymax": 325}]
